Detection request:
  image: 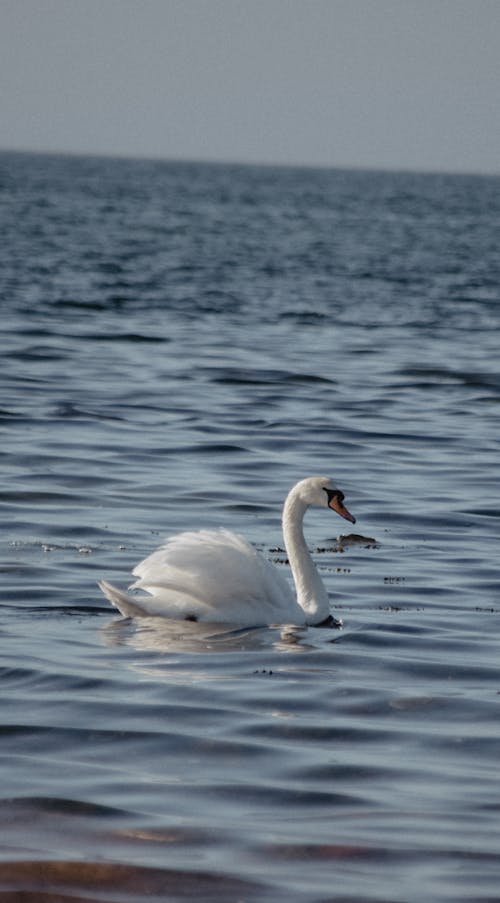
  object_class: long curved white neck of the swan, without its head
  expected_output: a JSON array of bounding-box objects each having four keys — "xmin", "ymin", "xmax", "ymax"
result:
[{"xmin": 283, "ymin": 490, "xmax": 330, "ymax": 624}]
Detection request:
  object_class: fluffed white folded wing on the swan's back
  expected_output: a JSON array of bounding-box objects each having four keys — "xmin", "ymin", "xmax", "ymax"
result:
[{"xmin": 131, "ymin": 530, "xmax": 296, "ymax": 624}]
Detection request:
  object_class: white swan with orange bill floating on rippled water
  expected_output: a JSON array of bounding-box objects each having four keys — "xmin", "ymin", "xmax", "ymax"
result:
[{"xmin": 98, "ymin": 477, "xmax": 356, "ymax": 627}]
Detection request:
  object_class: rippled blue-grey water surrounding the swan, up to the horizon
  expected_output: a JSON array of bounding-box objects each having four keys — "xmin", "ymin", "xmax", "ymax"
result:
[{"xmin": 0, "ymin": 153, "xmax": 500, "ymax": 903}]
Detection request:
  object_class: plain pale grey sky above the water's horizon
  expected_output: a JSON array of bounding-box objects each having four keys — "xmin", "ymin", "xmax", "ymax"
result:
[{"xmin": 0, "ymin": 0, "xmax": 500, "ymax": 173}]
